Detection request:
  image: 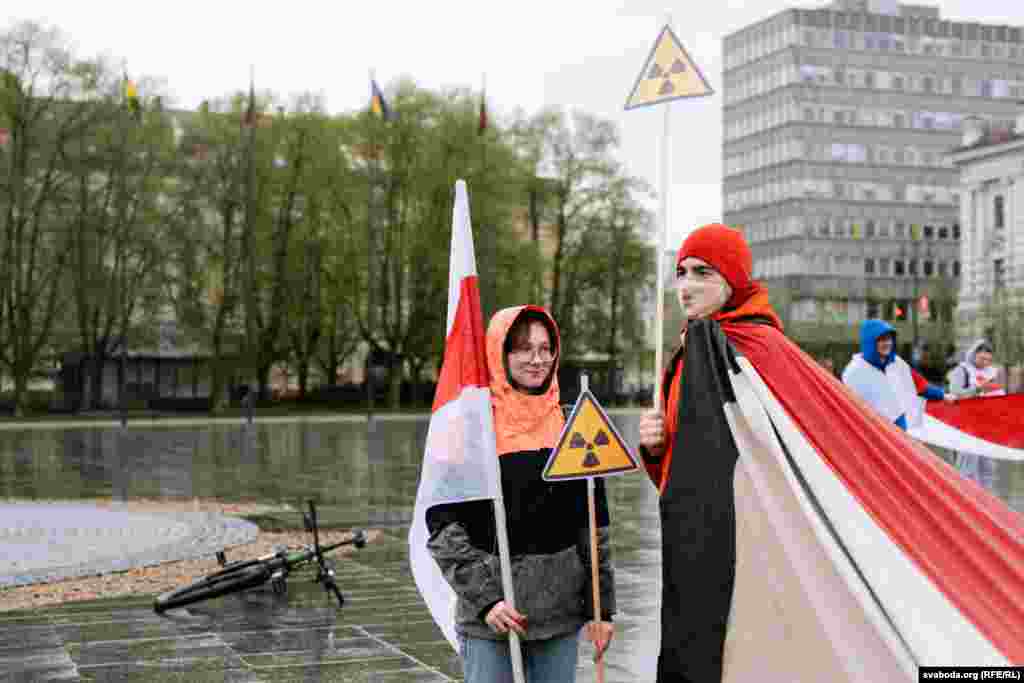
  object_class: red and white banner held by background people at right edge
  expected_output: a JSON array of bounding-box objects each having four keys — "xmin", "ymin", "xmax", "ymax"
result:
[{"xmin": 910, "ymin": 393, "xmax": 1024, "ymax": 461}]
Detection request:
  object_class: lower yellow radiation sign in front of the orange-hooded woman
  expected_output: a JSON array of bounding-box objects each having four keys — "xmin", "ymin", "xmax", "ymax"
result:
[{"xmin": 544, "ymin": 389, "xmax": 640, "ymax": 481}]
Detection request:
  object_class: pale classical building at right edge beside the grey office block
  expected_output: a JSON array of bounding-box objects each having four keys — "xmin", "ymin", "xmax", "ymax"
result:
[{"xmin": 949, "ymin": 113, "xmax": 1024, "ymax": 346}]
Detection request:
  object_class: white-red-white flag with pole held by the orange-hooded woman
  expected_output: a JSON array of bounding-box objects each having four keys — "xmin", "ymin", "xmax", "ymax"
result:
[{"xmin": 409, "ymin": 180, "xmax": 525, "ymax": 683}]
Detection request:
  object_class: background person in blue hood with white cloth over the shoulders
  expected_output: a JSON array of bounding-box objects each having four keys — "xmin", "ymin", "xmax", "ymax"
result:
[{"xmin": 843, "ymin": 317, "xmax": 956, "ymax": 431}]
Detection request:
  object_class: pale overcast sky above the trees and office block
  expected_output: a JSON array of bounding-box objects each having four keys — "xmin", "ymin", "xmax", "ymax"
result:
[{"xmin": 0, "ymin": 0, "xmax": 1024, "ymax": 248}]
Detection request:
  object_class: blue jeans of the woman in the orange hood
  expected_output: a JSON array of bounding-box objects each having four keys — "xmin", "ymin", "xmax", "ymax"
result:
[{"xmin": 459, "ymin": 632, "xmax": 580, "ymax": 683}]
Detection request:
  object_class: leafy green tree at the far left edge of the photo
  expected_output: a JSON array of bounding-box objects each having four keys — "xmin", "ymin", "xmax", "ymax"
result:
[{"xmin": 0, "ymin": 22, "xmax": 110, "ymax": 415}]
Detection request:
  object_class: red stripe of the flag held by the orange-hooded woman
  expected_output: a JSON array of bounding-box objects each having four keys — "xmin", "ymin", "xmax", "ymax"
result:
[{"xmin": 432, "ymin": 275, "xmax": 489, "ymax": 413}]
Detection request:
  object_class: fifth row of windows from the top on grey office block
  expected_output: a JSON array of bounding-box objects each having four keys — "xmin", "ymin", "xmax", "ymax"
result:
[{"xmin": 723, "ymin": 178, "xmax": 959, "ymax": 211}]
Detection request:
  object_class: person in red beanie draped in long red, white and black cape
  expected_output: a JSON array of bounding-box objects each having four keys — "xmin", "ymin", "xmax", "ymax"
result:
[{"xmin": 640, "ymin": 224, "xmax": 1024, "ymax": 683}]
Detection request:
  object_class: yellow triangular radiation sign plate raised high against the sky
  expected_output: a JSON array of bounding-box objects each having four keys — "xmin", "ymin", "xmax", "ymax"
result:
[{"xmin": 626, "ymin": 25, "xmax": 714, "ymax": 110}]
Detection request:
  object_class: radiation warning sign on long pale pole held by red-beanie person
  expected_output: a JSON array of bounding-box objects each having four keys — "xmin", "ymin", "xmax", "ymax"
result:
[{"xmin": 626, "ymin": 14, "xmax": 714, "ymax": 409}]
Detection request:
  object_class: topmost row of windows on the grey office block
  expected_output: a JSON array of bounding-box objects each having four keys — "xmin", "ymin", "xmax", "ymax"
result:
[{"xmin": 724, "ymin": 24, "xmax": 1024, "ymax": 71}]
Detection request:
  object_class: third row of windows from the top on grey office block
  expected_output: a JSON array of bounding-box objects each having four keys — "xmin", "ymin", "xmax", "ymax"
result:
[{"xmin": 723, "ymin": 99, "xmax": 970, "ymax": 141}]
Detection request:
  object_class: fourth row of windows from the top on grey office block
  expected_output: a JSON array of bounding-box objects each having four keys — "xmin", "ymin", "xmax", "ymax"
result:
[{"xmin": 724, "ymin": 138, "xmax": 952, "ymax": 177}]
